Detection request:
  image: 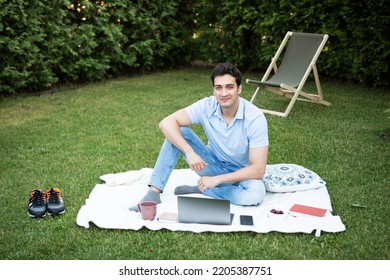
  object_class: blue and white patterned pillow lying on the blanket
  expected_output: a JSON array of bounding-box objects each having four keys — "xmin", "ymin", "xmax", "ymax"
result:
[{"xmin": 263, "ymin": 163, "xmax": 326, "ymax": 192}]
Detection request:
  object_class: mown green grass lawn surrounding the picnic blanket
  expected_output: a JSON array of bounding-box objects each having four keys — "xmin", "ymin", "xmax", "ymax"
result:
[{"xmin": 0, "ymin": 68, "xmax": 390, "ymax": 260}]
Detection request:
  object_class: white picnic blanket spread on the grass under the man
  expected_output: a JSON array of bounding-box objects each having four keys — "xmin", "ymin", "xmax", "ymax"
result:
[{"xmin": 77, "ymin": 168, "xmax": 345, "ymax": 236}]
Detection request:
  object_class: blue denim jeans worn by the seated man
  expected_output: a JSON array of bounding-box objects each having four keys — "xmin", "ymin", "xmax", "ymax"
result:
[{"xmin": 149, "ymin": 127, "xmax": 265, "ymax": 205}]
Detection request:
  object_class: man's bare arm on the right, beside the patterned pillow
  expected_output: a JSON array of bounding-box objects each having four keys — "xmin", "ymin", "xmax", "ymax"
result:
[{"xmin": 198, "ymin": 146, "xmax": 268, "ymax": 191}]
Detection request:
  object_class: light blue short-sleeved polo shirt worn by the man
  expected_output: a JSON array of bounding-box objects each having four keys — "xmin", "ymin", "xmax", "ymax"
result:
[{"xmin": 186, "ymin": 96, "xmax": 268, "ymax": 167}]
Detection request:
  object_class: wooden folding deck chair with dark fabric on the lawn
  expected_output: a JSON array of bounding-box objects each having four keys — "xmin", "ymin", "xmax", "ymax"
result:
[{"xmin": 246, "ymin": 31, "xmax": 330, "ymax": 117}]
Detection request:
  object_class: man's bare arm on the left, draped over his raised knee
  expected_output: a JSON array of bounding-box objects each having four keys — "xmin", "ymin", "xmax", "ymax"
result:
[{"xmin": 159, "ymin": 109, "xmax": 207, "ymax": 171}]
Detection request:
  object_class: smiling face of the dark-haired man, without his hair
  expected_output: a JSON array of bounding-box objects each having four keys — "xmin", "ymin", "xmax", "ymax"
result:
[{"xmin": 213, "ymin": 74, "xmax": 242, "ymax": 109}]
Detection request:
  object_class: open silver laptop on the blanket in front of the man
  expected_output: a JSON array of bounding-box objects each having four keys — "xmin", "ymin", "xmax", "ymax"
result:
[{"xmin": 177, "ymin": 196, "xmax": 233, "ymax": 225}]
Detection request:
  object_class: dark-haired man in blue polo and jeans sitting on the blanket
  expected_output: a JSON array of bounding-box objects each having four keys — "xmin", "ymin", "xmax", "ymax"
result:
[{"xmin": 130, "ymin": 63, "xmax": 268, "ymax": 211}]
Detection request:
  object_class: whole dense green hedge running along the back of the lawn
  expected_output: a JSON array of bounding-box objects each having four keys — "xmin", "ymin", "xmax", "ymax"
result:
[{"xmin": 0, "ymin": 0, "xmax": 390, "ymax": 93}]
